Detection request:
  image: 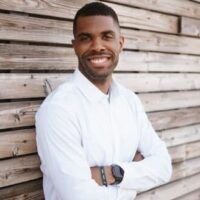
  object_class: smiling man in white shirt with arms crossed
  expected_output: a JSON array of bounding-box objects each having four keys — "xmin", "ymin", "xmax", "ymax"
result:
[{"xmin": 36, "ymin": 3, "xmax": 172, "ymax": 200}]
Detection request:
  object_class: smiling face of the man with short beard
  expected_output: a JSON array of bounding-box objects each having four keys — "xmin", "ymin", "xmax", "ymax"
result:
[{"xmin": 72, "ymin": 16, "xmax": 124, "ymax": 82}]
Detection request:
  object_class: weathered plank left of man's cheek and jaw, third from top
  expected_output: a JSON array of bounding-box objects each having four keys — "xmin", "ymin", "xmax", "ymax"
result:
[{"xmin": 0, "ymin": 43, "xmax": 78, "ymax": 70}]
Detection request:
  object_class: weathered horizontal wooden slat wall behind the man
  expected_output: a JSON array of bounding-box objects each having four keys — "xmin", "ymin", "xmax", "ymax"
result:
[{"xmin": 0, "ymin": 0, "xmax": 200, "ymax": 200}]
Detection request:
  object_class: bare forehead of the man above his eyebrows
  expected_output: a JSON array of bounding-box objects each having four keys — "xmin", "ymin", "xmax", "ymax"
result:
[{"xmin": 76, "ymin": 16, "xmax": 119, "ymax": 34}]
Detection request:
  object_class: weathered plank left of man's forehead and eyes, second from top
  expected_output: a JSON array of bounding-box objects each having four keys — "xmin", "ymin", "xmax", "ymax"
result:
[{"xmin": 0, "ymin": 13, "xmax": 72, "ymax": 44}]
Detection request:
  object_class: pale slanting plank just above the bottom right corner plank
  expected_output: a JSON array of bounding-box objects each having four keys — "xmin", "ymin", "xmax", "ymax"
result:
[{"xmin": 136, "ymin": 174, "xmax": 200, "ymax": 200}]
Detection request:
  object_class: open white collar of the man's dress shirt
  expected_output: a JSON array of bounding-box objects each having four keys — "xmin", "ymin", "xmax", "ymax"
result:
[{"xmin": 73, "ymin": 68, "xmax": 118, "ymax": 102}]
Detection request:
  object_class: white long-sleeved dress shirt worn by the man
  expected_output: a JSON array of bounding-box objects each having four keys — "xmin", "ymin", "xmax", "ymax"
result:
[{"xmin": 36, "ymin": 70, "xmax": 172, "ymax": 200}]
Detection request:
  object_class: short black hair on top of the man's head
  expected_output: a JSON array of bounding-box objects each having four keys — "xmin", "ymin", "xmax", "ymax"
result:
[{"xmin": 73, "ymin": 2, "xmax": 119, "ymax": 36}]
